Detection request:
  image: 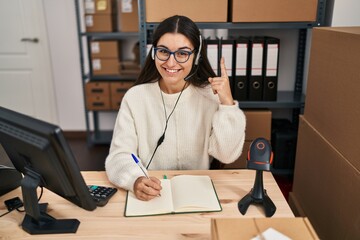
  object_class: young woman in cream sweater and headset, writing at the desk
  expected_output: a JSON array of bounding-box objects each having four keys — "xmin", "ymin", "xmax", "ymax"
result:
[{"xmin": 105, "ymin": 16, "xmax": 246, "ymax": 200}]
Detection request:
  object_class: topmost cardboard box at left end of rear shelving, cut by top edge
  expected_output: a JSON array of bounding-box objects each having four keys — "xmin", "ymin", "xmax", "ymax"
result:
[{"xmin": 84, "ymin": 0, "xmax": 116, "ymax": 14}]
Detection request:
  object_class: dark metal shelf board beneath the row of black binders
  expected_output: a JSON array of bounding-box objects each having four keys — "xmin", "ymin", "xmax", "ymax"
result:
[{"xmin": 239, "ymin": 91, "xmax": 305, "ymax": 109}]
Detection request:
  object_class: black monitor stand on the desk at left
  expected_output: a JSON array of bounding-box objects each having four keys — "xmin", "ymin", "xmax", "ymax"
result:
[{"xmin": 21, "ymin": 169, "xmax": 80, "ymax": 234}]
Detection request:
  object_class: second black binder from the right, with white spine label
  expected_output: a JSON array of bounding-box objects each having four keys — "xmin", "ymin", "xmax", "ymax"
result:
[{"xmin": 248, "ymin": 37, "xmax": 264, "ymax": 101}]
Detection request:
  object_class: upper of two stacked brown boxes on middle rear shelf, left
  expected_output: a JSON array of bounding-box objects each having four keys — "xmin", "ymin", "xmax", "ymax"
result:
[{"xmin": 90, "ymin": 41, "xmax": 120, "ymax": 59}]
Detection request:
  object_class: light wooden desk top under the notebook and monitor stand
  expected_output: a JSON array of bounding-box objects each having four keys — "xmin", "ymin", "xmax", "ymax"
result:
[{"xmin": 0, "ymin": 170, "xmax": 294, "ymax": 240}]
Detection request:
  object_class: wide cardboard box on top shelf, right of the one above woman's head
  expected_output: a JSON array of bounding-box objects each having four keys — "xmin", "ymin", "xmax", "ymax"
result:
[{"xmin": 231, "ymin": 0, "xmax": 318, "ymax": 22}]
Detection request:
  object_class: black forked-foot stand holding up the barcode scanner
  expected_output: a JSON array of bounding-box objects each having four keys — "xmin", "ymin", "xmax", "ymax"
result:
[{"xmin": 238, "ymin": 170, "xmax": 276, "ymax": 217}]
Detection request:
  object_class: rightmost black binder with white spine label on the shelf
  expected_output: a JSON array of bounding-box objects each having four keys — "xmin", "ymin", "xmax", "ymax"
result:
[{"xmin": 263, "ymin": 37, "xmax": 280, "ymax": 101}]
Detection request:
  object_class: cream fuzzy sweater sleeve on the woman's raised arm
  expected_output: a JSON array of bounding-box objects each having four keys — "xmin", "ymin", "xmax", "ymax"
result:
[{"xmin": 209, "ymin": 101, "xmax": 246, "ymax": 164}]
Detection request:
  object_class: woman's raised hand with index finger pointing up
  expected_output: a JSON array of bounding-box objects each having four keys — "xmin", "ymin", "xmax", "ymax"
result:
[{"xmin": 208, "ymin": 57, "xmax": 234, "ymax": 105}]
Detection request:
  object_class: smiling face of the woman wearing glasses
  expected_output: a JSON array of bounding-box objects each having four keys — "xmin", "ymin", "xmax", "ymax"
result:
[{"xmin": 155, "ymin": 33, "xmax": 195, "ymax": 90}]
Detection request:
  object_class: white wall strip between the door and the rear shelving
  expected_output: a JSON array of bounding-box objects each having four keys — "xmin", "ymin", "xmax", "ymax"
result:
[{"xmin": 43, "ymin": 0, "xmax": 86, "ymax": 130}]
